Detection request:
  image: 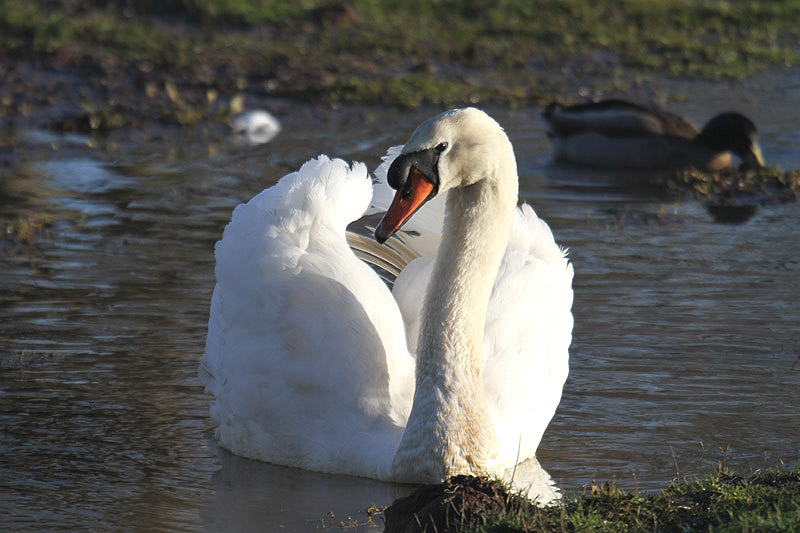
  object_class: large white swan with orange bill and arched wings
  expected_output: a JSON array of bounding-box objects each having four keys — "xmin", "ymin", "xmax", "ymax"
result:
[{"xmin": 200, "ymin": 108, "xmax": 572, "ymax": 494}]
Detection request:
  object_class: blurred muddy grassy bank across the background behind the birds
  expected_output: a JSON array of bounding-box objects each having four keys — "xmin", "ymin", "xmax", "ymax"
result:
[{"xmin": 0, "ymin": 0, "xmax": 800, "ymax": 128}]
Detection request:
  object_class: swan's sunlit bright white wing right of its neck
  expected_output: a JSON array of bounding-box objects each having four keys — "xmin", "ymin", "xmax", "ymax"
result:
[{"xmin": 483, "ymin": 205, "xmax": 573, "ymax": 465}]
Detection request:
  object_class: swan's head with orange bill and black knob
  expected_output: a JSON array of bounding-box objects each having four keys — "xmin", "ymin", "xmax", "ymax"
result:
[{"xmin": 375, "ymin": 107, "xmax": 516, "ymax": 243}]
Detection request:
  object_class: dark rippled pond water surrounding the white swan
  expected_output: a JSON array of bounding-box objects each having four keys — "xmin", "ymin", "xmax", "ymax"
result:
[{"xmin": 0, "ymin": 83, "xmax": 800, "ymax": 531}]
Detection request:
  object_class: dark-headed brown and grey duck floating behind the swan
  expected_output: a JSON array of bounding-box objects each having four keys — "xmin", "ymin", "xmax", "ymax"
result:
[{"xmin": 542, "ymin": 99, "xmax": 764, "ymax": 168}]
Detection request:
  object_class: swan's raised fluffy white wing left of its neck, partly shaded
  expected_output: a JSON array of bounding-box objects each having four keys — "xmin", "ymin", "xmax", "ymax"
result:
[{"xmin": 200, "ymin": 156, "xmax": 413, "ymax": 478}]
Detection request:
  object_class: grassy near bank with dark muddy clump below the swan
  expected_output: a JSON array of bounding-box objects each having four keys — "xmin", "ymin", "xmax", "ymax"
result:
[{"xmin": 385, "ymin": 468, "xmax": 800, "ymax": 533}]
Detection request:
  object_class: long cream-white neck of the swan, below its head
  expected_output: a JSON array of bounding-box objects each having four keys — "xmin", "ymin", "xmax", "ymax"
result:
[{"xmin": 392, "ymin": 144, "xmax": 517, "ymax": 483}]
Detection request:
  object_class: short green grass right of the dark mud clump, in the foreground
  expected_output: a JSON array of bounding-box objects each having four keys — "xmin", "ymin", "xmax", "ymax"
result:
[{"xmin": 500, "ymin": 468, "xmax": 800, "ymax": 532}]
